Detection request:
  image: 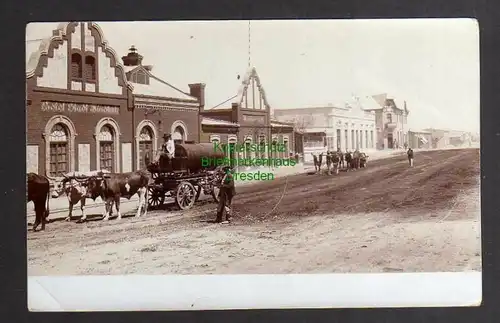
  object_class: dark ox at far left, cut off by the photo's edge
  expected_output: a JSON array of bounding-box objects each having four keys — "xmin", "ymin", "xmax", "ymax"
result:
[{"xmin": 26, "ymin": 173, "xmax": 50, "ymax": 231}]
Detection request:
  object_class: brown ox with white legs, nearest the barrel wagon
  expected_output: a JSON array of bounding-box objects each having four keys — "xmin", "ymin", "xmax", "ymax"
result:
[{"xmin": 87, "ymin": 170, "xmax": 149, "ymax": 220}]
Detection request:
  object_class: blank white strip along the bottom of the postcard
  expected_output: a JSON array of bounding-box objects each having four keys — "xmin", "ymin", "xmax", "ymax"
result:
[{"xmin": 28, "ymin": 272, "xmax": 482, "ymax": 311}]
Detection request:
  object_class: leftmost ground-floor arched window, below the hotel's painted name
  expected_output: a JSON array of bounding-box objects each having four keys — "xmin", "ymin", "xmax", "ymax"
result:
[{"xmin": 49, "ymin": 123, "xmax": 69, "ymax": 176}]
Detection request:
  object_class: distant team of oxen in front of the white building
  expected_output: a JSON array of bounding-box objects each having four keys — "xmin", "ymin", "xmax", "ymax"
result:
[{"xmin": 312, "ymin": 149, "xmax": 368, "ymax": 175}]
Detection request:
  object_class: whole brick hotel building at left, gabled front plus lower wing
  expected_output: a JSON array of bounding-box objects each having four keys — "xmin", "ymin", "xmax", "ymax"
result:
[{"xmin": 26, "ymin": 22, "xmax": 202, "ymax": 176}]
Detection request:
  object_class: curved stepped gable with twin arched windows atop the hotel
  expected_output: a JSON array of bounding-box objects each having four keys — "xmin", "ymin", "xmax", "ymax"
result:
[{"xmin": 26, "ymin": 22, "xmax": 132, "ymax": 95}]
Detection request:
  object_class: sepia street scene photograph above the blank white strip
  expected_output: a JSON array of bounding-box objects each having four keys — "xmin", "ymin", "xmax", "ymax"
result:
[{"xmin": 25, "ymin": 19, "xmax": 481, "ymax": 312}]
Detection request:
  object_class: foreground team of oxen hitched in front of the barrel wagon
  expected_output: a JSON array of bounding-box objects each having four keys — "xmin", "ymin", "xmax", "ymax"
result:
[{"xmin": 27, "ymin": 170, "xmax": 150, "ymax": 231}]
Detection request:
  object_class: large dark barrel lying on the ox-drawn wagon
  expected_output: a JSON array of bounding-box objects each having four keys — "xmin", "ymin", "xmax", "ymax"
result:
[{"xmin": 149, "ymin": 143, "xmax": 225, "ymax": 174}]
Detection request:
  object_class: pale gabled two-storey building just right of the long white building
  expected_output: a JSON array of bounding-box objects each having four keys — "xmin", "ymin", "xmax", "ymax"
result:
[{"xmin": 361, "ymin": 93, "xmax": 410, "ymax": 149}]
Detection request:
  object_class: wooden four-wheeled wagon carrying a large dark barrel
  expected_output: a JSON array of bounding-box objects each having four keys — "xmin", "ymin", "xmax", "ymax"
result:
[{"xmin": 146, "ymin": 143, "xmax": 224, "ymax": 210}]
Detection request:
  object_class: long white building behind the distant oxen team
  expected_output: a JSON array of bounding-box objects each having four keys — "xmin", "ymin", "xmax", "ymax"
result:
[{"xmin": 274, "ymin": 100, "xmax": 377, "ymax": 162}]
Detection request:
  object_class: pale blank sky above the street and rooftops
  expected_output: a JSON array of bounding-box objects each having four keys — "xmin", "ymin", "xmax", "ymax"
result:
[{"xmin": 26, "ymin": 19, "xmax": 480, "ymax": 132}]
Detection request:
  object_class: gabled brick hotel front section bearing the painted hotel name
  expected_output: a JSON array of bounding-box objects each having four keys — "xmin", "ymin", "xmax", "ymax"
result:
[{"xmin": 26, "ymin": 22, "xmax": 134, "ymax": 176}]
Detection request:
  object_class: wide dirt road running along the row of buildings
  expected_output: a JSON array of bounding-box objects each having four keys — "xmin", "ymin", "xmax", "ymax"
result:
[{"xmin": 28, "ymin": 149, "xmax": 481, "ymax": 275}]
